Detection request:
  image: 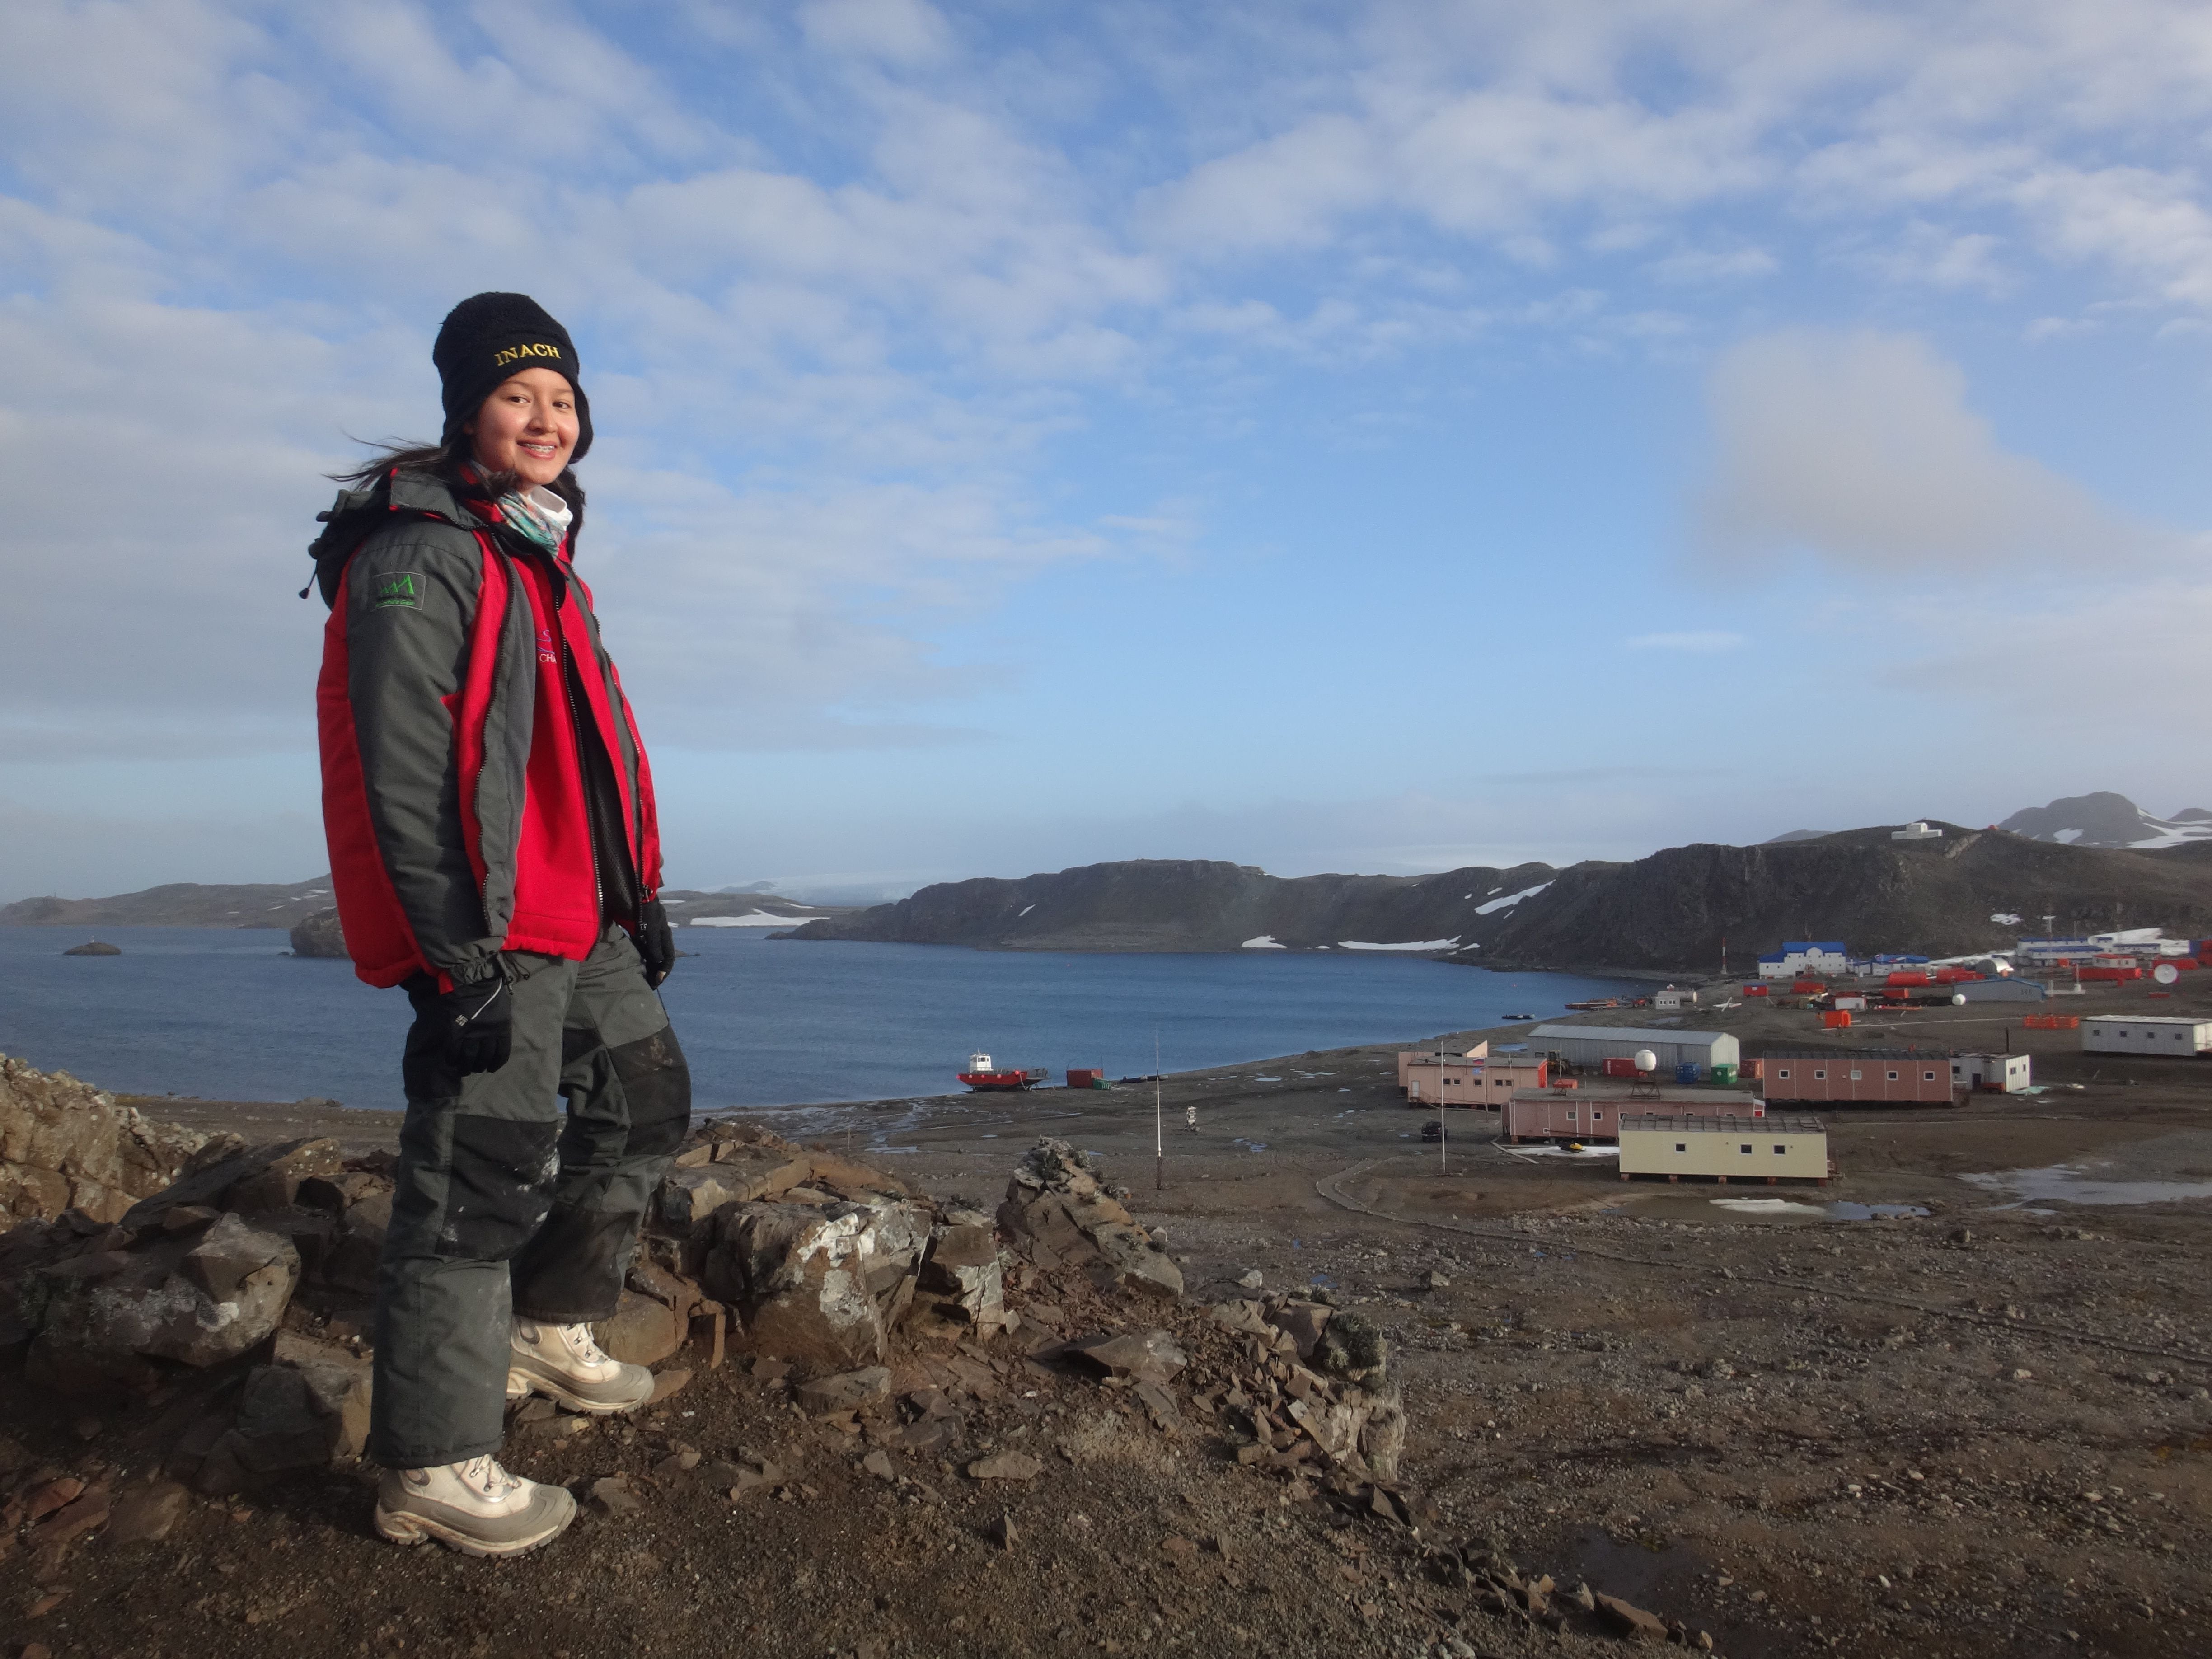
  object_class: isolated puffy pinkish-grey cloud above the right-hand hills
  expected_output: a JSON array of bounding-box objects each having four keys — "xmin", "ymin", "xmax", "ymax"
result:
[{"xmin": 1696, "ymin": 330, "xmax": 2152, "ymax": 571}]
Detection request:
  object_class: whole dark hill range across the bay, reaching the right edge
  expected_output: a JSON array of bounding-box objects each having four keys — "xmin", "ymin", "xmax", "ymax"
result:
[{"xmin": 776, "ymin": 825, "xmax": 2212, "ymax": 973}]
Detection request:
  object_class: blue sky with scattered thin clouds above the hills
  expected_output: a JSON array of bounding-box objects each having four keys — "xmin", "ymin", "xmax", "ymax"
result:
[{"xmin": 0, "ymin": 0, "xmax": 2212, "ymax": 900}]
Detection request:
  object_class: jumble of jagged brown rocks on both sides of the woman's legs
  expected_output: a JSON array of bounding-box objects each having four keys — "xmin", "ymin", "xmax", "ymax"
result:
[{"xmin": 0, "ymin": 1121, "xmax": 1427, "ymax": 1610}]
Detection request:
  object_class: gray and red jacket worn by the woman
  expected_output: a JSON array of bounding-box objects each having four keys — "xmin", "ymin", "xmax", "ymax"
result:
[{"xmin": 312, "ymin": 471, "xmax": 661, "ymax": 987}]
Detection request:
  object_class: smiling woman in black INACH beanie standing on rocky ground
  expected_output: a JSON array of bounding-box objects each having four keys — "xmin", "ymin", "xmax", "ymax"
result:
[{"xmin": 309, "ymin": 294, "xmax": 690, "ymax": 1555}]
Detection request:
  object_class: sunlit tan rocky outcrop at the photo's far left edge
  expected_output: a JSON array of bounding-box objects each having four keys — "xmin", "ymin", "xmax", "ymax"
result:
[{"xmin": 0, "ymin": 1055, "xmax": 208, "ymax": 1228}]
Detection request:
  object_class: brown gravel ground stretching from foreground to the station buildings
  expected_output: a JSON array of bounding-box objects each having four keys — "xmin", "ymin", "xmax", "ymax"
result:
[{"xmin": 0, "ymin": 1007, "xmax": 2212, "ymax": 1659}]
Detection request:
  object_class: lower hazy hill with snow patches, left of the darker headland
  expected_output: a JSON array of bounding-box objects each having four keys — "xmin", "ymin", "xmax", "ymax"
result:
[{"xmin": 776, "ymin": 858, "xmax": 1555, "ymax": 951}]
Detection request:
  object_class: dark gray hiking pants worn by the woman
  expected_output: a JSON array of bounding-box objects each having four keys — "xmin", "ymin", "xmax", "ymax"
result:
[{"xmin": 370, "ymin": 927, "xmax": 690, "ymax": 1469}]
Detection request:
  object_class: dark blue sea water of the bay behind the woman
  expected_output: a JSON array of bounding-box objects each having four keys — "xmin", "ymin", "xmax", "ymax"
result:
[{"xmin": 0, "ymin": 927, "xmax": 1624, "ymax": 1108}]
